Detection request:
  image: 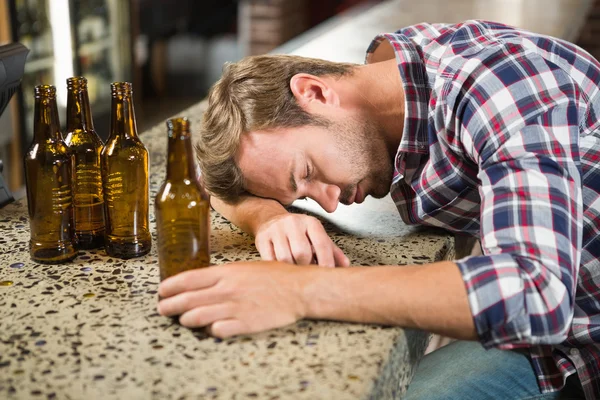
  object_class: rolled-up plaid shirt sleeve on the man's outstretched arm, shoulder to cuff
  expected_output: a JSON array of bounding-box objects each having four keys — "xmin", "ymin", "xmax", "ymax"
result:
[{"xmin": 457, "ymin": 55, "xmax": 583, "ymax": 349}]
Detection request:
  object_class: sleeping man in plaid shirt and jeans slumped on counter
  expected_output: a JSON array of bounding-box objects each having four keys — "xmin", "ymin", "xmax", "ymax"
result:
[{"xmin": 159, "ymin": 21, "xmax": 600, "ymax": 399}]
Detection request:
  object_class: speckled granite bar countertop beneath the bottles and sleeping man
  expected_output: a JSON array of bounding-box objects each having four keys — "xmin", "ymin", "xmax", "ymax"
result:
[{"xmin": 0, "ymin": 0, "xmax": 587, "ymax": 400}]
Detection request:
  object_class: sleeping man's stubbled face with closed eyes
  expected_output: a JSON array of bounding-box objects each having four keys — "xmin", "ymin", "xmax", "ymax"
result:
[{"xmin": 237, "ymin": 112, "xmax": 393, "ymax": 212}]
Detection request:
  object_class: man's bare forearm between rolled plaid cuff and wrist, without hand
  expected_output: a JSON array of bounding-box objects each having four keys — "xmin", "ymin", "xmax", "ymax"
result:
[{"xmin": 303, "ymin": 261, "xmax": 477, "ymax": 340}]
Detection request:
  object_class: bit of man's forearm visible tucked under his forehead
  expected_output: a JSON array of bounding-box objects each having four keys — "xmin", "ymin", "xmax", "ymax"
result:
[{"xmin": 210, "ymin": 196, "xmax": 288, "ymax": 235}]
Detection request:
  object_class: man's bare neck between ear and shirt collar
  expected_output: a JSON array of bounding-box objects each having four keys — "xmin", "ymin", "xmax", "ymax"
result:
[{"xmin": 350, "ymin": 59, "xmax": 404, "ymax": 157}]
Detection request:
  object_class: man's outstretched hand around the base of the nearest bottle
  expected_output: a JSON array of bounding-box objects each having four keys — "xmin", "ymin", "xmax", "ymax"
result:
[{"xmin": 158, "ymin": 262, "xmax": 324, "ymax": 338}]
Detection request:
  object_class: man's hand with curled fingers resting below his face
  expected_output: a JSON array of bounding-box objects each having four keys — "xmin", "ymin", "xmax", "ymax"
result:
[{"xmin": 255, "ymin": 213, "xmax": 350, "ymax": 267}]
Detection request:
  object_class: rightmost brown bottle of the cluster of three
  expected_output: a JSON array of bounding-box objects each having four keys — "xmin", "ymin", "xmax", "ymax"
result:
[{"xmin": 101, "ymin": 82, "xmax": 152, "ymax": 258}]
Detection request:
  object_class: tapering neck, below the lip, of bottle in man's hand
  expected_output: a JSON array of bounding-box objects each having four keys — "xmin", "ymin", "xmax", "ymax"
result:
[{"xmin": 167, "ymin": 132, "xmax": 196, "ymax": 181}]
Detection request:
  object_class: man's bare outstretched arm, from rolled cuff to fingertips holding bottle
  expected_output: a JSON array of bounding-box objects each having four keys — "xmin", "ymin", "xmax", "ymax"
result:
[{"xmin": 158, "ymin": 262, "xmax": 476, "ymax": 339}]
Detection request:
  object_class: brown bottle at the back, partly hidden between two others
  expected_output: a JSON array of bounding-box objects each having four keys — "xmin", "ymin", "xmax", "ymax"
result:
[{"xmin": 65, "ymin": 77, "xmax": 104, "ymax": 249}]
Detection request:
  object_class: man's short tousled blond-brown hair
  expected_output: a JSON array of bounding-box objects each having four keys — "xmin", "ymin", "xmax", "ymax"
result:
[{"xmin": 196, "ymin": 55, "xmax": 355, "ymax": 203}]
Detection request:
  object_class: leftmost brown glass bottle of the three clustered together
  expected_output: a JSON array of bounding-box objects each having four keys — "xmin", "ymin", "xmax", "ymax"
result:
[{"xmin": 25, "ymin": 85, "xmax": 77, "ymax": 264}]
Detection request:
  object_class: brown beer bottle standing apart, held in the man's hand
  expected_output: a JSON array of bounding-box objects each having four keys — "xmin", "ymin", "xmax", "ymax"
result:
[{"xmin": 154, "ymin": 118, "xmax": 210, "ymax": 280}]
